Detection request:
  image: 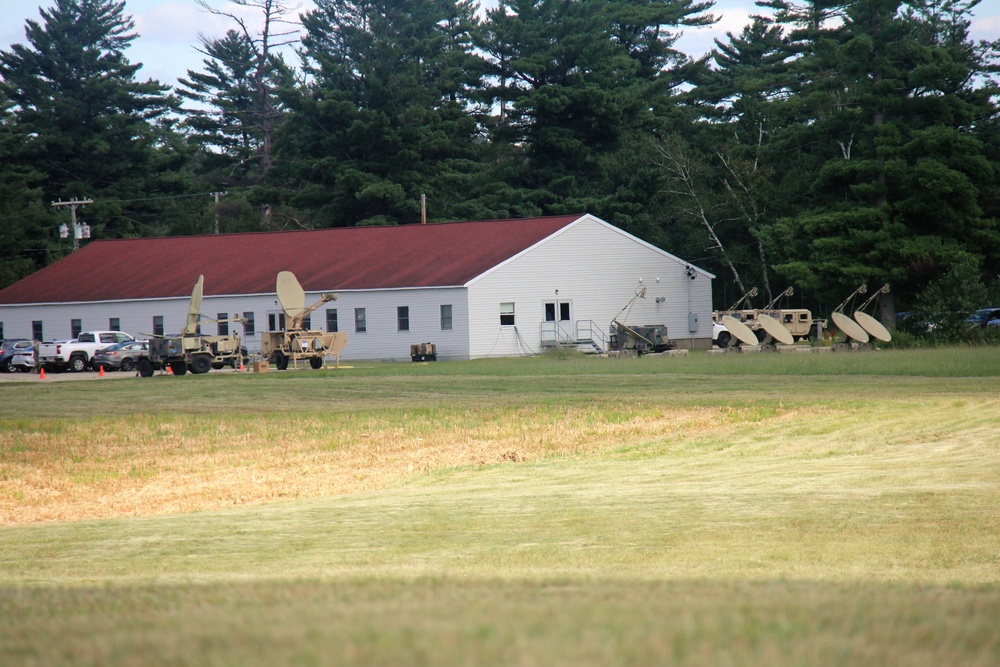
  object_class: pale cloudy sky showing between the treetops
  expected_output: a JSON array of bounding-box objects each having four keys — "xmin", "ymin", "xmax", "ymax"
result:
[{"xmin": 0, "ymin": 0, "xmax": 1000, "ymax": 85}]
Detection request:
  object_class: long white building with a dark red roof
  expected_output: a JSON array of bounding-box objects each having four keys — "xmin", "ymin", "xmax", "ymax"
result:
[{"xmin": 0, "ymin": 215, "xmax": 714, "ymax": 360}]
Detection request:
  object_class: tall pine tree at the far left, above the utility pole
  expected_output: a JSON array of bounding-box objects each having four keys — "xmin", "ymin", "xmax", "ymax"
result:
[{"xmin": 0, "ymin": 0, "xmax": 184, "ymax": 244}]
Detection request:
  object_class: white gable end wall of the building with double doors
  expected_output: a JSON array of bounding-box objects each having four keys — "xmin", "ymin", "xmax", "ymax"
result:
[{"xmin": 469, "ymin": 216, "xmax": 712, "ymax": 358}]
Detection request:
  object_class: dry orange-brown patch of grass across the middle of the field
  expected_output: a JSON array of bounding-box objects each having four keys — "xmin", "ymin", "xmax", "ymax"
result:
[{"xmin": 0, "ymin": 407, "xmax": 760, "ymax": 525}]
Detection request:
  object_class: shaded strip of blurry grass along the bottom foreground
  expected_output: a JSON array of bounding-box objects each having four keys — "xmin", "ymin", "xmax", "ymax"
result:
[{"xmin": 0, "ymin": 578, "xmax": 1000, "ymax": 667}]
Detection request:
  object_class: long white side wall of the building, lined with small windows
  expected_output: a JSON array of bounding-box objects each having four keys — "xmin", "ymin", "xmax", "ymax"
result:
[{"xmin": 0, "ymin": 288, "xmax": 469, "ymax": 360}]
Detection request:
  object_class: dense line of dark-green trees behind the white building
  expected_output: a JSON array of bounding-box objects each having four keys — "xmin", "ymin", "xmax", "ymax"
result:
[{"xmin": 0, "ymin": 0, "xmax": 1000, "ymax": 311}]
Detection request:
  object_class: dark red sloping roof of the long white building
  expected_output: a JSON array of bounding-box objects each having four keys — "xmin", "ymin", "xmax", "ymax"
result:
[{"xmin": 0, "ymin": 215, "xmax": 581, "ymax": 304}]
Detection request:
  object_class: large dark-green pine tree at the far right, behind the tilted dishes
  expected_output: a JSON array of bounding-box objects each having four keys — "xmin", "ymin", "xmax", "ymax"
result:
[{"xmin": 756, "ymin": 0, "xmax": 1000, "ymax": 310}]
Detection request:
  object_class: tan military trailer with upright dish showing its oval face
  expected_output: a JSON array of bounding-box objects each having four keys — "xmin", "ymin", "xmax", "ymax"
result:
[{"xmin": 260, "ymin": 271, "xmax": 347, "ymax": 371}]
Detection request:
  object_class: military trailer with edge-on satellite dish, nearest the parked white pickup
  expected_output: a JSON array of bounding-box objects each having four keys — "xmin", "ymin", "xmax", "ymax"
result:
[{"xmin": 136, "ymin": 276, "xmax": 244, "ymax": 377}]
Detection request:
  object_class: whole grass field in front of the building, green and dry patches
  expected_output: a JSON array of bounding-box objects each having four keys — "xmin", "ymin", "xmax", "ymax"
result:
[{"xmin": 0, "ymin": 348, "xmax": 1000, "ymax": 666}]
